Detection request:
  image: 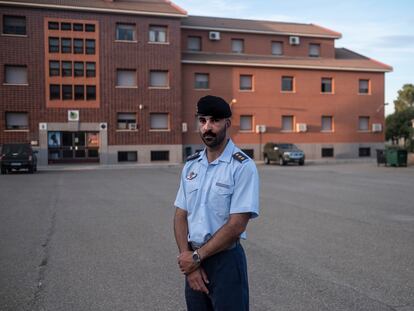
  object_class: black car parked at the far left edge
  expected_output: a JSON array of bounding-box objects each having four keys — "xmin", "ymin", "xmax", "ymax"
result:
[{"xmin": 0, "ymin": 143, "xmax": 37, "ymax": 174}]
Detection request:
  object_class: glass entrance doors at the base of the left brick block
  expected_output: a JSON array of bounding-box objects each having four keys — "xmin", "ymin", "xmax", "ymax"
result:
[{"xmin": 48, "ymin": 131, "xmax": 99, "ymax": 163}]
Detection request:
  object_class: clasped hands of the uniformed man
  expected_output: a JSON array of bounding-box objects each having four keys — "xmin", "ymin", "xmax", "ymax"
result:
[{"xmin": 177, "ymin": 251, "xmax": 209, "ymax": 294}]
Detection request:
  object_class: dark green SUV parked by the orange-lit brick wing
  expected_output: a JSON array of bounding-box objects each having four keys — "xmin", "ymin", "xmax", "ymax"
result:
[{"xmin": 263, "ymin": 143, "xmax": 305, "ymax": 165}]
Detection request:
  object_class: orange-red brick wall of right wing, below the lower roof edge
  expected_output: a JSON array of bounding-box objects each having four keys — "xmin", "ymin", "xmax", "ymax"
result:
[{"xmin": 183, "ymin": 64, "xmax": 384, "ymax": 144}]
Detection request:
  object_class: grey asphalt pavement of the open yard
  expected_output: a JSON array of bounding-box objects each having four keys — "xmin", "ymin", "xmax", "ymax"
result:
[{"xmin": 0, "ymin": 163, "xmax": 414, "ymax": 311}]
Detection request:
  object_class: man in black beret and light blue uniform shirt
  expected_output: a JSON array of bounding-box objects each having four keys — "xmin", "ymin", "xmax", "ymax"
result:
[{"xmin": 174, "ymin": 96, "xmax": 259, "ymax": 311}]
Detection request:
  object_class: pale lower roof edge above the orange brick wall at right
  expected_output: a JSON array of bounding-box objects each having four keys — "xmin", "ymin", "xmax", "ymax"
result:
[{"xmin": 181, "ymin": 59, "xmax": 392, "ymax": 73}]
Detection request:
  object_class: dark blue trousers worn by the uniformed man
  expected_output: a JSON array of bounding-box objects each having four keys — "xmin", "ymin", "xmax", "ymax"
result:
[{"xmin": 185, "ymin": 243, "xmax": 249, "ymax": 311}]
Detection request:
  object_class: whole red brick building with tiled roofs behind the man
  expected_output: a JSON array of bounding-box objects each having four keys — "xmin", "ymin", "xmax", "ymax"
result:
[{"xmin": 0, "ymin": 0, "xmax": 392, "ymax": 165}]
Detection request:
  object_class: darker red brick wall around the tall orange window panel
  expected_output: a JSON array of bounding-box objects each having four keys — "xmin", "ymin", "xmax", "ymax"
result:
[{"xmin": 0, "ymin": 7, "xmax": 182, "ymax": 145}]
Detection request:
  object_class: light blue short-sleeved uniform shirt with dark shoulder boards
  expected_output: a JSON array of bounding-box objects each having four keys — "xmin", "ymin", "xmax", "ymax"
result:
[{"xmin": 174, "ymin": 139, "xmax": 259, "ymax": 244}]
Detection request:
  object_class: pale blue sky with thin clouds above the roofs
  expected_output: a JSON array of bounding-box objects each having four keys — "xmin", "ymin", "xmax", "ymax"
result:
[{"xmin": 172, "ymin": 0, "xmax": 414, "ymax": 115}]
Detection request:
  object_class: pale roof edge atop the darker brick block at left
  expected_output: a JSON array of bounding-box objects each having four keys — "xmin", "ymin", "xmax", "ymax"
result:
[{"xmin": 0, "ymin": 1, "xmax": 187, "ymax": 18}]
